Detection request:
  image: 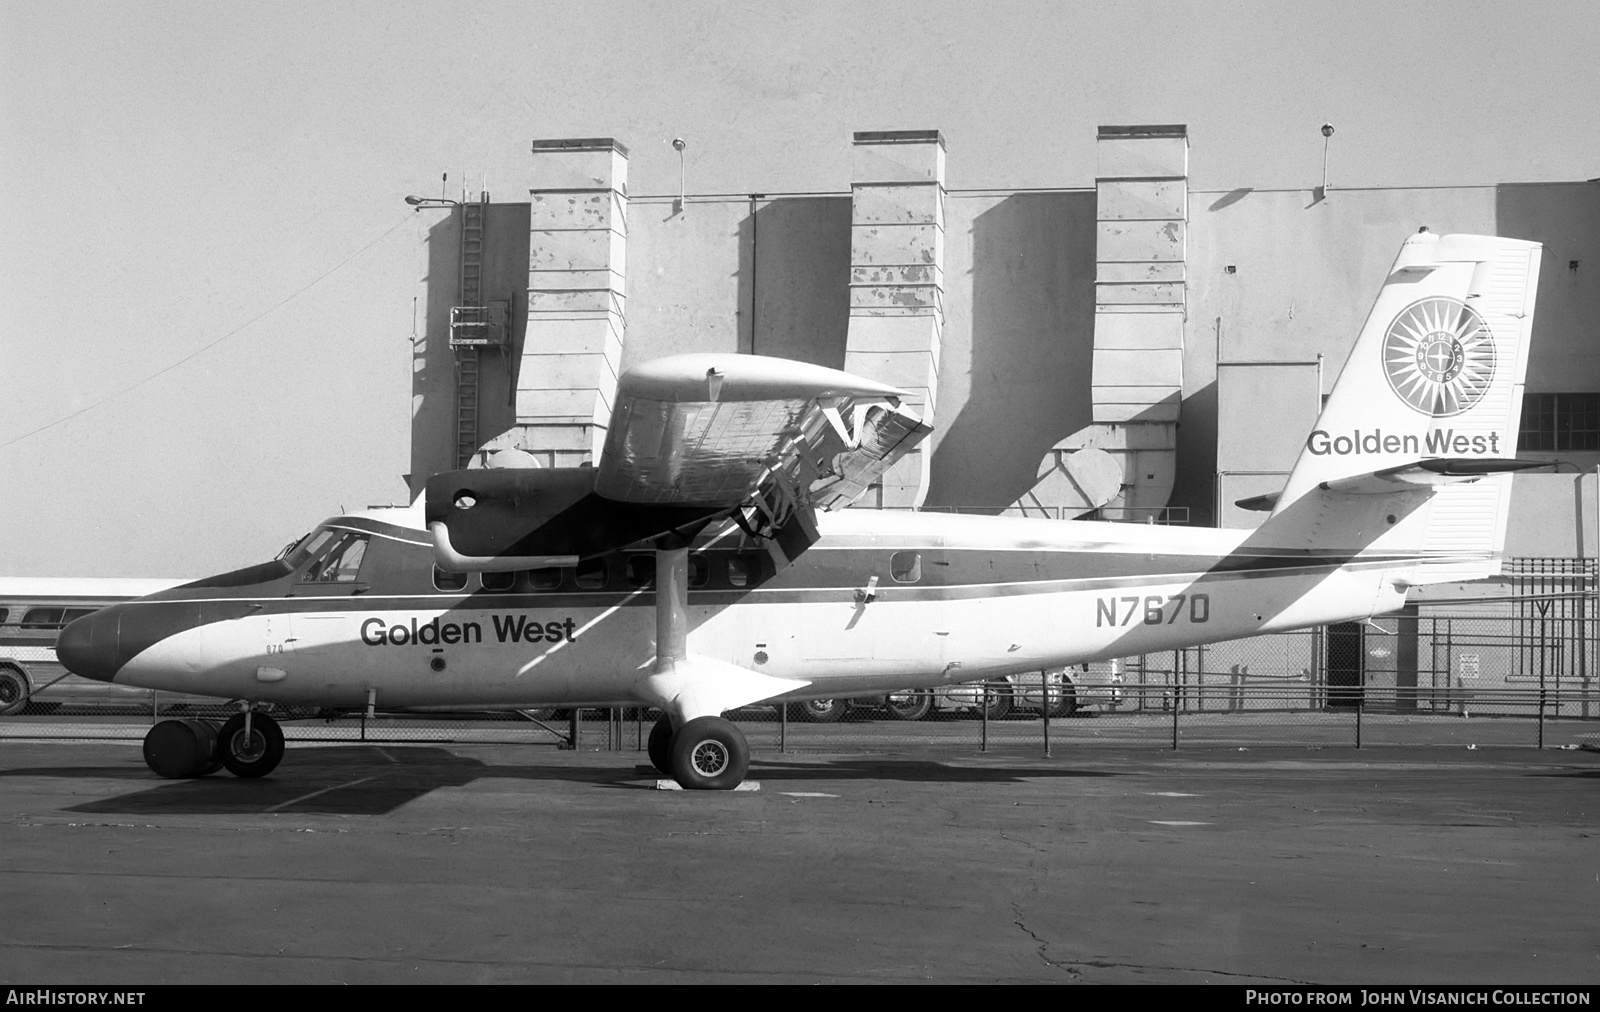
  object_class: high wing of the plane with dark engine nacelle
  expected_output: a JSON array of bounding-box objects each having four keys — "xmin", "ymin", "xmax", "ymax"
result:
[{"xmin": 427, "ymin": 354, "xmax": 931, "ymax": 572}]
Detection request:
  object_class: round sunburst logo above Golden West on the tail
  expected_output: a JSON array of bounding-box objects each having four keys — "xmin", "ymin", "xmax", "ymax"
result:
[{"xmin": 1384, "ymin": 296, "xmax": 1496, "ymax": 418}]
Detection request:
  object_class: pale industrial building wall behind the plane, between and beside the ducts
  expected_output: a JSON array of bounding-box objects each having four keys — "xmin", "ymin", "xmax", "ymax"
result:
[{"xmin": 413, "ymin": 183, "xmax": 1600, "ymax": 536}]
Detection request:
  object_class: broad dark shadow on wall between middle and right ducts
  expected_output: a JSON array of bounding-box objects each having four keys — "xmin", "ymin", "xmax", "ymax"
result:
[{"xmin": 928, "ymin": 192, "xmax": 1094, "ymax": 512}]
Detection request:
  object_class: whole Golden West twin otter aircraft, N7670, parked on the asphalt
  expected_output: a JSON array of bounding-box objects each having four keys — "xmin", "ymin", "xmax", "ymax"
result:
[{"xmin": 58, "ymin": 231, "xmax": 1539, "ymax": 789}]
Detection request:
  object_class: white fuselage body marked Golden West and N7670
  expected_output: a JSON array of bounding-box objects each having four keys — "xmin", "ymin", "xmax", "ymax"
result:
[{"xmin": 100, "ymin": 511, "xmax": 1411, "ymax": 708}]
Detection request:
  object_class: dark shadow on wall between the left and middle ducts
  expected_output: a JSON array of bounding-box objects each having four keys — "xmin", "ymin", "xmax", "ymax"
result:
[{"xmin": 739, "ymin": 197, "xmax": 851, "ymax": 368}]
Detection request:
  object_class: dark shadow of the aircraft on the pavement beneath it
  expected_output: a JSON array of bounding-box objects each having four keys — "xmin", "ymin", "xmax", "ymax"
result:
[{"xmin": 0, "ymin": 746, "xmax": 1120, "ymax": 815}]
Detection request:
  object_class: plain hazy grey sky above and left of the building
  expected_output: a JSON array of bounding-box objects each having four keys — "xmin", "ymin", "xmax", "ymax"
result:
[{"xmin": 0, "ymin": 0, "xmax": 1600, "ymax": 576}]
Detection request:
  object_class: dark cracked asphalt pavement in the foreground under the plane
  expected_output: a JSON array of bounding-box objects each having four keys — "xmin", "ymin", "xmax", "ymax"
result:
[{"xmin": 0, "ymin": 741, "xmax": 1600, "ymax": 985}]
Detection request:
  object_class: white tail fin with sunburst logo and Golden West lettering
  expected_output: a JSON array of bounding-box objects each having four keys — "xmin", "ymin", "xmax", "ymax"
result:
[{"xmin": 1262, "ymin": 232, "xmax": 1541, "ymax": 583}]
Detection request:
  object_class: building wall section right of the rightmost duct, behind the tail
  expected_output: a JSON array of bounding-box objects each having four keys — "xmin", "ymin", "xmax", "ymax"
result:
[{"xmin": 1173, "ymin": 183, "xmax": 1600, "ymax": 528}]
